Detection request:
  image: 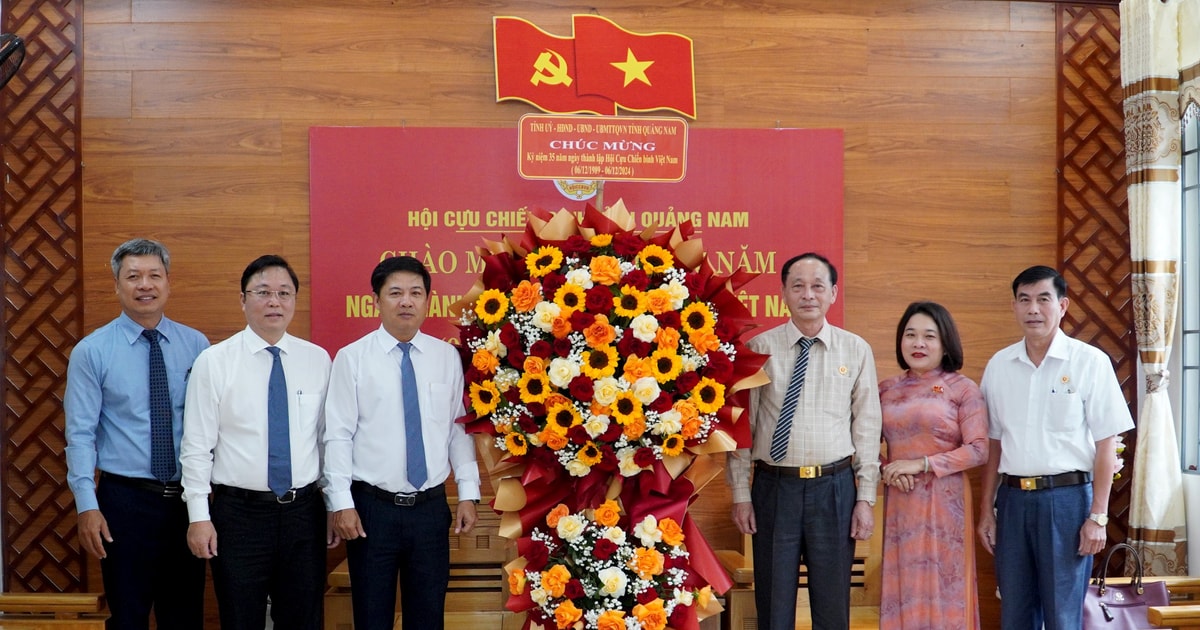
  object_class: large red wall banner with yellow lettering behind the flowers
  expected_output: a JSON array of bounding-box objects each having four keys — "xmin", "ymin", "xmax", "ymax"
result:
[{"xmin": 310, "ymin": 126, "xmax": 846, "ymax": 352}]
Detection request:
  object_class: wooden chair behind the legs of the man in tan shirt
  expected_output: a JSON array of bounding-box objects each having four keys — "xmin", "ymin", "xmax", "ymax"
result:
[{"xmin": 716, "ymin": 497, "xmax": 883, "ymax": 630}]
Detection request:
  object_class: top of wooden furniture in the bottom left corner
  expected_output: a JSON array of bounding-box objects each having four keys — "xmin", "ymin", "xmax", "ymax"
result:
[{"xmin": 0, "ymin": 593, "xmax": 108, "ymax": 630}]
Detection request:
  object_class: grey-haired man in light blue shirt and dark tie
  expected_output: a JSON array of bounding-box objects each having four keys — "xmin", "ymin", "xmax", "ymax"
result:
[{"xmin": 65, "ymin": 239, "xmax": 209, "ymax": 630}]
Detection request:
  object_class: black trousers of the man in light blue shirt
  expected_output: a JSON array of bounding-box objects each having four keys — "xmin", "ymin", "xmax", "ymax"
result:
[{"xmin": 96, "ymin": 479, "xmax": 204, "ymax": 630}]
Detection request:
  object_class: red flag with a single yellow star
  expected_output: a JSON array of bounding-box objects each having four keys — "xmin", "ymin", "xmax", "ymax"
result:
[{"xmin": 572, "ymin": 14, "xmax": 696, "ymax": 119}]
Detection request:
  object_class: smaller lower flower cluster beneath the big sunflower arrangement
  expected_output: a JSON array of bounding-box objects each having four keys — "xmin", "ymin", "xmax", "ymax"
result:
[{"xmin": 509, "ymin": 500, "xmax": 714, "ymax": 630}]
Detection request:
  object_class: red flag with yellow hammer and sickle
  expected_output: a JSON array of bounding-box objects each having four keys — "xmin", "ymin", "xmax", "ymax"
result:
[{"xmin": 492, "ymin": 17, "xmax": 617, "ymax": 115}]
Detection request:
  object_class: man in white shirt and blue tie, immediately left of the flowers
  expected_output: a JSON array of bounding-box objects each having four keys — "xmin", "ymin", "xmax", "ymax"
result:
[{"xmin": 325, "ymin": 256, "xmax": 480, "ymax": 630}]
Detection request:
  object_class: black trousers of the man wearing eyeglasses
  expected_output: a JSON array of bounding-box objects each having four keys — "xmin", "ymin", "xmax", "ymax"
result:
[{"xmin": 212, "ymin": 490, "xmax": 325, "ymax": 630}]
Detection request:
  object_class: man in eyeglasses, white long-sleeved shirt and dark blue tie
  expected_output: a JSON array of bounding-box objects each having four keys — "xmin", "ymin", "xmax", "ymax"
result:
[{"xmin": 181, "ymin": 256, "xmax": 337, "ymax": 630}]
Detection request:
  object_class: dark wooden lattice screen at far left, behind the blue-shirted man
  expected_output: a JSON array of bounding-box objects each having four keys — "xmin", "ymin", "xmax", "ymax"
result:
[{"xmin": 0, "ymin": 0, "xmax": 86, "ymax": 592}]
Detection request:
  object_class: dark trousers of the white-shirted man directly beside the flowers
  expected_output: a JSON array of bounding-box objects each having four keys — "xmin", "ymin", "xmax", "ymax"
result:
[{"xmin": 346, "ymin": 484, "xmax": 452, "ymax": 630}]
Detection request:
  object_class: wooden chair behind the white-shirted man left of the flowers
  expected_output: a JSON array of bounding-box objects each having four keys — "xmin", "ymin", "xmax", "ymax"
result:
[{"xmin": 325, "ymin": 498, "xmax": 523, "ymax": 630}]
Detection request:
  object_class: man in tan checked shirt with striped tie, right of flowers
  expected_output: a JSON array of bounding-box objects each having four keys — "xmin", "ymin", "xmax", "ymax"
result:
[{"xmin": 726, "ymin": 252, "xmax": 882, "ymax": 630}]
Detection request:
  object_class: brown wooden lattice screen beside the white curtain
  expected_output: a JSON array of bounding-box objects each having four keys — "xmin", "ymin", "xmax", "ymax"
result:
[{"xmin": 1057, "ymin": 5, "xmax": 1138, "ymax": 575}]
